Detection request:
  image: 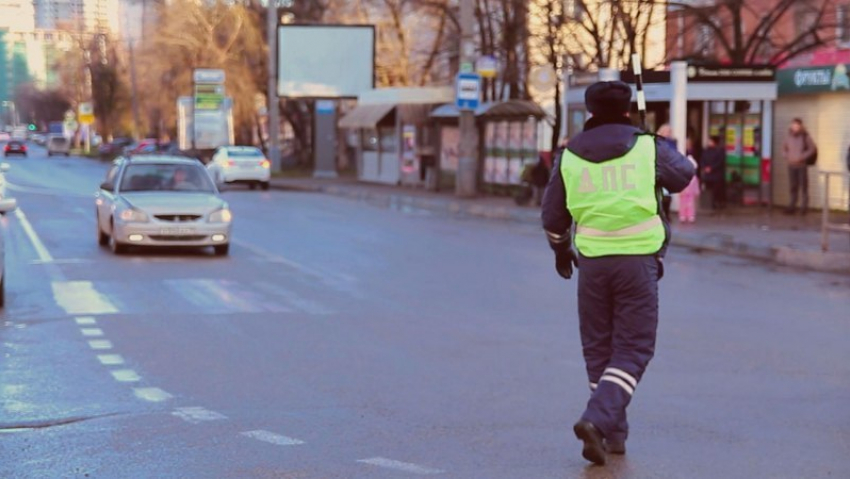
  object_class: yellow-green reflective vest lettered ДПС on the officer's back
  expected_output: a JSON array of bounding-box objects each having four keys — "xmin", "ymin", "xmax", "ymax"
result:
[{"xmin": 561, "ymin": 135, "xmax": 666, "ymax": 258}]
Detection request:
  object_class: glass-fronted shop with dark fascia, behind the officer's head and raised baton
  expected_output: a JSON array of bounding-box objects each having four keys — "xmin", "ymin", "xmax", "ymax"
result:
[{"xmin": 567, "ymin": 65, "xmax": 777, "ymax": 205}]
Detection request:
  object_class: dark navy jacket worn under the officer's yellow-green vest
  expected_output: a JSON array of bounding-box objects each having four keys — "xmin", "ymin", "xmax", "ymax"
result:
[{"xmin": 543, "ymin": 117, "xmax": 696, "ymax": 255}]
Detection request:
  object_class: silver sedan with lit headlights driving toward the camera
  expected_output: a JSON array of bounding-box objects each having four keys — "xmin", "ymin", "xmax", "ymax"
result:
[{"xmin": 95, "ymin": 155, "xmax": 233, "ymax": 256}]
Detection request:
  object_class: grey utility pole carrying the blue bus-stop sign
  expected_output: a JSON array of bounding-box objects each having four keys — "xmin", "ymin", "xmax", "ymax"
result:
[{"xmin": 455, "ymin": 0, "xmax": 478, "ymax": 198}]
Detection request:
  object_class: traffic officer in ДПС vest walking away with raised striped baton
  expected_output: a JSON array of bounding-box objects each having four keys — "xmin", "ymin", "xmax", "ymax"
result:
[{"xmin": 542, "ymin": 81, "xmax": 695, "ymax": 464}]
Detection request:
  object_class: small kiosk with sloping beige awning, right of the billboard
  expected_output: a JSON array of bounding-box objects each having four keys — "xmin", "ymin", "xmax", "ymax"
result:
[{"xmin": 339, "ymin": 88, "xmax": 454, "ymax": 186}]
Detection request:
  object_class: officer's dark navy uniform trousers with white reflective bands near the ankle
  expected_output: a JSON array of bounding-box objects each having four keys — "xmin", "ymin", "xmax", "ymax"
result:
[{"xmin": 578, "ymin": 256, "xmax": 659, "ymax": 442}]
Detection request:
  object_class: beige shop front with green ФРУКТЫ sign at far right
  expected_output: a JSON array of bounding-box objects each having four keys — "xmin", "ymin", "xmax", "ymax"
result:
[{"xmin": 773, "ymin": 64, "xmax": 850, "ymax": 211}]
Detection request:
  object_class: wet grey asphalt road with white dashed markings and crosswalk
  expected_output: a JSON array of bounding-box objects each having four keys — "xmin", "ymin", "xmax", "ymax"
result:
[{"xmin": 0, "ymin": 144, "xmax": 850, "ymax": 479}]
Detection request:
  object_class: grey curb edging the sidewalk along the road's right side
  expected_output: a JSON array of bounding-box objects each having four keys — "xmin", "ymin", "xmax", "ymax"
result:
[{"xmin": 271, "ymin": 183, "xmax": 850, "ymax": 275}]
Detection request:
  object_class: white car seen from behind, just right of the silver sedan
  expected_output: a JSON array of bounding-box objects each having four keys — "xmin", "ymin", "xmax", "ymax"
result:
[{"xmin": 207, "ymin": 146, "xmax": 271, "ymax": 190}]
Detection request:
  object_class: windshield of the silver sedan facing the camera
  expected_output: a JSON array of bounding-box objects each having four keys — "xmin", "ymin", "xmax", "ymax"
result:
[{"xmin": 121, "ymin": 163, "xmax": 215, "ymax": 193}]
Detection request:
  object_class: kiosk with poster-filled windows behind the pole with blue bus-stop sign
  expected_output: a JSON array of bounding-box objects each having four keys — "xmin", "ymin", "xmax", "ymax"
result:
[{"xmin": 431, "ymin": 100, "xmax": 546, "ymax": 193}]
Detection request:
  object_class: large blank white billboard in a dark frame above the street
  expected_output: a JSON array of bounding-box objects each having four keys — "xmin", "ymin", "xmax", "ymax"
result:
[{"xmin": 277, "ymin": 25, "xmax": 375, "ymax": 98}]
